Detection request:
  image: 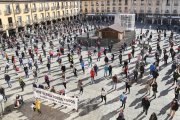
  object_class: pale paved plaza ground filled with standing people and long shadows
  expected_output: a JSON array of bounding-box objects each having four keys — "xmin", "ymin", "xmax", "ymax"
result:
[{"xmin": 0, "ymin": 1, "xmax": 180, "ymax": 120}]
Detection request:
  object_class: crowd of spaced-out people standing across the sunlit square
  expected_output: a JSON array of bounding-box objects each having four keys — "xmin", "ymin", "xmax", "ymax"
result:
[{"xmin": 0, "ymin": 17, "xmax": 180, "ymax": 120}]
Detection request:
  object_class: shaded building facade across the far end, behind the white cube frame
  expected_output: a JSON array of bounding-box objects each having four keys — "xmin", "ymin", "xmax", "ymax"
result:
[{"xmin": 81, "ymin": 0, "xmax": 180, "ymax": 25}]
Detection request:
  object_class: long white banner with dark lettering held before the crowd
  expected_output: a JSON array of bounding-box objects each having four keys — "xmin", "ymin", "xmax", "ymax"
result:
[{"xmin": 34, "ymin": 88, "xmax": 78, "ymax": 110}]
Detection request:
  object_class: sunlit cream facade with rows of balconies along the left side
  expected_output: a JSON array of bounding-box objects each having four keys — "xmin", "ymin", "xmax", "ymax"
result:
[{"xmin": 0, "ymin": 0, "xmax": 80, "ymax": 35}]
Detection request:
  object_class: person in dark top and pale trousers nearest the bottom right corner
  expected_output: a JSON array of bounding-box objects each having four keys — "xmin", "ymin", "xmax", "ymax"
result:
[{"xmin": 168, "ymin": 99, "xmax": 179, "ymax": 118}]
